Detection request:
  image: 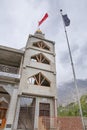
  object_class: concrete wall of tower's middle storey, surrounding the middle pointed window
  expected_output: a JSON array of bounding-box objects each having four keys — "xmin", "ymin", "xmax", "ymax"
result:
[{"xmin": 23, "ymin": 49, "xmax": 56, "ymax": 72}]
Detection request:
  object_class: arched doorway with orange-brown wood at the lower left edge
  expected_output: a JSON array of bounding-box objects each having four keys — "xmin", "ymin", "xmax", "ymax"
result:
[{"xmin": 0, "ymin": 86, "xmax": 10, "ymax": 129}]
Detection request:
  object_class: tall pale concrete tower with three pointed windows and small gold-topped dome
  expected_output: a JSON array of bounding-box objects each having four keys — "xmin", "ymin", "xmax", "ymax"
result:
[{"xmin": 16, "ymin": 29, "xmax": 57, "ymax": 130}]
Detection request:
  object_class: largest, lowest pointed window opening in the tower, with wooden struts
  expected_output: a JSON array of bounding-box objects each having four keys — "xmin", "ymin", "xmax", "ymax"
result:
[{"xmin": 28, "ymin": 72, "xmax": 50, "ymax": 87}]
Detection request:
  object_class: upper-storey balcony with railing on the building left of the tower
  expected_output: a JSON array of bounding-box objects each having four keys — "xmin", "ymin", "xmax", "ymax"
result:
[{"xmin": 0, "ymin": 45, "xmax": 24, "ymax": 83}]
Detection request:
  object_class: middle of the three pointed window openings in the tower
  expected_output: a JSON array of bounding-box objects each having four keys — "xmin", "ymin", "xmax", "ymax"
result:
[{"xmin": 31, "ymin": 53, "xmax": 50, "ymax": 64}]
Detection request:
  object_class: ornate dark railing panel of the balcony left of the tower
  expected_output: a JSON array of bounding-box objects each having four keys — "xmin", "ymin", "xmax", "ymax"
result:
[{"xmin": 0, "ymin": 64, "xmax": 19, "ymax": 74}]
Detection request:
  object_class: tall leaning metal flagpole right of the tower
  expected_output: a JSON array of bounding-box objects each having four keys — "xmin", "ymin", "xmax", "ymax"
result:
[{"xmin": 60, "ymin": 10, "xmax": 85, "ymax": 130}]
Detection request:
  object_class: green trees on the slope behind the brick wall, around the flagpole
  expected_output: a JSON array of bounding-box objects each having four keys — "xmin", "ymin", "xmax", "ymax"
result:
[{"xmin": 58, "ymin": 95, "xmax": 87, "ymax": 117}]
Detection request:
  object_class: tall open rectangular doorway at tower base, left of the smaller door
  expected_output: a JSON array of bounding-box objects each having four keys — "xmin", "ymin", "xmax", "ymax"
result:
[{"xmin": 17, "ymin": 95, "xmax": 36, "ymax": 130}]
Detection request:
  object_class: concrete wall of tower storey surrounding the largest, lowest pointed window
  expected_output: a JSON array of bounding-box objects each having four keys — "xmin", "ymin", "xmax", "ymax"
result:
[{"xmin": 19, "ymin": 67, "xmax": 56, "ymax": 97}]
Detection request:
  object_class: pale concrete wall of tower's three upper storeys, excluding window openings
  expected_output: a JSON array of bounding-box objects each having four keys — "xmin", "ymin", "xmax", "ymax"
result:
[{"xmin": 19, "ymin": 34, "xmax": 56, "ymax": 97}]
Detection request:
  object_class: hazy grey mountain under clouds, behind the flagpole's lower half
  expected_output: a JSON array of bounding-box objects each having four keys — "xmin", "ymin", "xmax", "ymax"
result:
[{"xmin": 57, "ymin": 79, "xmax": 87, "ymax": 105}]
